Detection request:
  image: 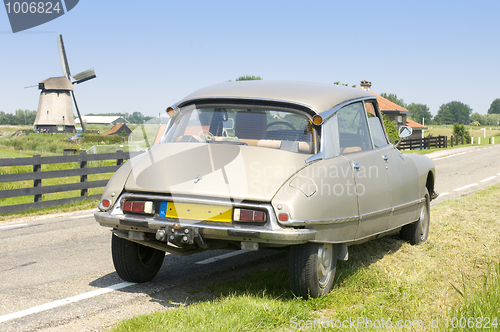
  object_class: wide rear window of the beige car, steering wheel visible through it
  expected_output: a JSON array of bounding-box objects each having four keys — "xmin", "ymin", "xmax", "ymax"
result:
[{"xmin": 162, "ymin": 105, "xmax": 315, "ymax": 154}]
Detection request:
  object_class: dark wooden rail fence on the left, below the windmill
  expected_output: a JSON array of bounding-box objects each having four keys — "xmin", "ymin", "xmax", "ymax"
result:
[{"xmin": 0, "ymin": 151, "xmax": 142, "ymax": 214}]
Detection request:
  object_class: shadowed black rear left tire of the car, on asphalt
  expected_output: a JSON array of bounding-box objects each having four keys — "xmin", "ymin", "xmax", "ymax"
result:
[{"xmin": 111, "ymin": 234, "xmax": 165, "ymax": 282}]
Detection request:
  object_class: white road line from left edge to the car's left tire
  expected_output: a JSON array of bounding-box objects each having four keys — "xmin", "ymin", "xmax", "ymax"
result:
[{"xmin": 0, "ymin": 282, "xmax": 135, "ymax": 323}]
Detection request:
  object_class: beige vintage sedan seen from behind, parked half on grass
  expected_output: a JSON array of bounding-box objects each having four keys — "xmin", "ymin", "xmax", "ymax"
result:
[{"xmin": 95, "ymin": 81, "xmax": 438, "ymax": 298}]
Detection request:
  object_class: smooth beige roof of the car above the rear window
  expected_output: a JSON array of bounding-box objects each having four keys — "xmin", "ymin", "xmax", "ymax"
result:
[{"xmin": 177, "ymin": 80, "xmax": 374, "ymax": 113}]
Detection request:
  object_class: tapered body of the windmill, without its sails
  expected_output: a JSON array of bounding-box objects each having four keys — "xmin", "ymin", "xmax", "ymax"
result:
[{"xmin": 34, "ymin": 76, "xmax": 76, "ymax": 133}]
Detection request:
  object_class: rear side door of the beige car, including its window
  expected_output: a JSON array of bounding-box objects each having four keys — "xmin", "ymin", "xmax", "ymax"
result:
[{"xmin": 337, "ymin": 102, "xmax": 391, "ymax": 239}]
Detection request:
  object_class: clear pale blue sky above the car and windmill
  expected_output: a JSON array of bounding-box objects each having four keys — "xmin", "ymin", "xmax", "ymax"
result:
[{"xmin": 0, "ymin": 0, "xmax": 500, "ymax": 116}]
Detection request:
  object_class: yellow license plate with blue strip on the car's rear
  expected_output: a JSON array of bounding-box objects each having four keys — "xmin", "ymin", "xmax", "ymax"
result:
[{"xmin": 160, "ymin": 202, "xmax": 233, "ymax": 222}]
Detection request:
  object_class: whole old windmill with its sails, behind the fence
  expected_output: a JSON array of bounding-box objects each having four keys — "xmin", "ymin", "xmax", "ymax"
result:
[{"xmin": 33, "ymin": 35, "xmax": 96, "ymax": 133}]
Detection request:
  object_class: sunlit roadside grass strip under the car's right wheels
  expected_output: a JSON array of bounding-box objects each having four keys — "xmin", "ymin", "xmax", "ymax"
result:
[{"xmin": 113, "ymin": 185, "xmax": 500, "ymax": 332}]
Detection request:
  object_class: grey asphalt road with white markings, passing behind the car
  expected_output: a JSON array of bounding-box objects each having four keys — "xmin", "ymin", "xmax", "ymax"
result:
[{"xmin": 0, "ymin": 145, "xmax": 500, "ymax": 332}]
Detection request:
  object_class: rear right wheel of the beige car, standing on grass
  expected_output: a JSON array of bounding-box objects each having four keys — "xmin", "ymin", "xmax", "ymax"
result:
[{"xmin": 289, "ymin": 243, "xmax": 338, "ymax": 299}]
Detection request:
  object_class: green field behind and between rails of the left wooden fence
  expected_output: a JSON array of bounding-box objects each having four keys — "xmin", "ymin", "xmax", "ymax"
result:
[{"xmin": 0, "ymin": 125, "xmax": 158, "ymax": 218}]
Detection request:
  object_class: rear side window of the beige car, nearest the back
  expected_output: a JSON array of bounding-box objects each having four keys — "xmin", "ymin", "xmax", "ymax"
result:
[{"xmin": 337, "ymin": 102, "xmax": 372, "ymax": 154}]
